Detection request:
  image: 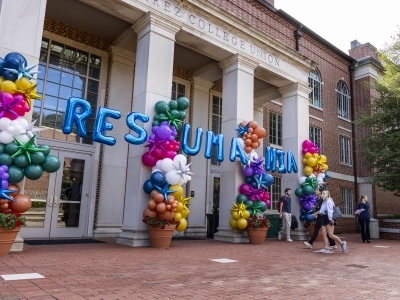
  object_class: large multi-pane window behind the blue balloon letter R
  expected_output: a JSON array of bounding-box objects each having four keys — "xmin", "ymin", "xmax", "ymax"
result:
[{"xmin": 32, "ymin": 38, "xmax": 101, "ymax": 144}]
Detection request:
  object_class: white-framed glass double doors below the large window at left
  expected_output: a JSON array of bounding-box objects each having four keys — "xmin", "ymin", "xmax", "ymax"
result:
[{"xmin": 20, "ymin": 151, "xmax": 92, "ymax": 238}]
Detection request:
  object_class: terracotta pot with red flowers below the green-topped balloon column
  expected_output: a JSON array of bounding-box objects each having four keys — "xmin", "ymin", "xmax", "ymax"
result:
[{"xmin": 143, "ymin": 216, "xmax": 179, "ymax": 248}]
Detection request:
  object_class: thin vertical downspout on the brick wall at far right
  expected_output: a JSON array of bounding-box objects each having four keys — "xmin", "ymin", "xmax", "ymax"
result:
[{"xmin": 349, "ymin": 63, "xmax": 360, "ymax": 232}]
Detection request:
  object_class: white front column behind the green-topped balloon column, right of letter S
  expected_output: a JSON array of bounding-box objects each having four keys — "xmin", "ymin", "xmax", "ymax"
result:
[{"xmin": 117, "ymin": 13, "xmax": 179, "ymax": 246}]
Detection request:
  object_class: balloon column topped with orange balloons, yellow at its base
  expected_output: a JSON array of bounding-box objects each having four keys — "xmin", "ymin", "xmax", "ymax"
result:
[{"xmin": 229, "ymin": 121, "xmax": 274, "ymax": 229}]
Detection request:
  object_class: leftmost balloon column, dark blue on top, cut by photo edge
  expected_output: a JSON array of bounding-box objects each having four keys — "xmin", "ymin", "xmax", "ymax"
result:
[{"xmin": 0, "ymin": 52, "xmax": 60, "ymax": 213}]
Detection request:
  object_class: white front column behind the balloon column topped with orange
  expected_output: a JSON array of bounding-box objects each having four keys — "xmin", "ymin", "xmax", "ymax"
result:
[{"xmin": 214, "ymin": 55, "xmax": 257, "ymax": 243}]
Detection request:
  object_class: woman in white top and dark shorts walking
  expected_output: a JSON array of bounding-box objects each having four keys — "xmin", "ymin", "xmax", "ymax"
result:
[{"xmin": 313, "ymin": 191, "xmax": 347, "ymax": 253}]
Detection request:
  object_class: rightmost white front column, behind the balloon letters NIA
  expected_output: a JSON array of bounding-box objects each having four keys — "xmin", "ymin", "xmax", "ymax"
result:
[{"xmin": 279, "ymin": 83, "xmax": 310, "ymax": 240}]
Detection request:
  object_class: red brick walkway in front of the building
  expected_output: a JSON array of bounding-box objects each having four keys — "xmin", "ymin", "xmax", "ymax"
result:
[{"xmin": 0, "ymin": 234, "xmax": 400, "ymax": 300}]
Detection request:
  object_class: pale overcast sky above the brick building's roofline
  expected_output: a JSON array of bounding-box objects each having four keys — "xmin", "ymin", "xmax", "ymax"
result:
[{"xmin": 275, "ymin": 0, "xmax": 400, "ymax": 54}]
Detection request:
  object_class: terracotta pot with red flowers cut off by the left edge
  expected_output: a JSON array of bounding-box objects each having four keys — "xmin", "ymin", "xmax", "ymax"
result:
[{"xmin": 0, "ymin": 209, "xmax": 26, "ymax": 256}]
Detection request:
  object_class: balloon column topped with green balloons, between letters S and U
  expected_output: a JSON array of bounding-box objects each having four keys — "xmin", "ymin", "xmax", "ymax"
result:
[{"xmin": 142, "ymin": 97, "xmax": 193, "ymax": 231}]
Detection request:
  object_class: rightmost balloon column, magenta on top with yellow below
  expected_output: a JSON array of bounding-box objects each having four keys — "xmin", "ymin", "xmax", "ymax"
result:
[{"xmin": 295, "ymin": 140, "xmax": 328, "ymax": 222}]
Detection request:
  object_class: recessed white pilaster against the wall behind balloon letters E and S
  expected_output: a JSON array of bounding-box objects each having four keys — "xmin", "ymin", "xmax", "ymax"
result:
[{"xmin": 94, "ymin": 46, "xmax": 135, "ymax": 237}]
